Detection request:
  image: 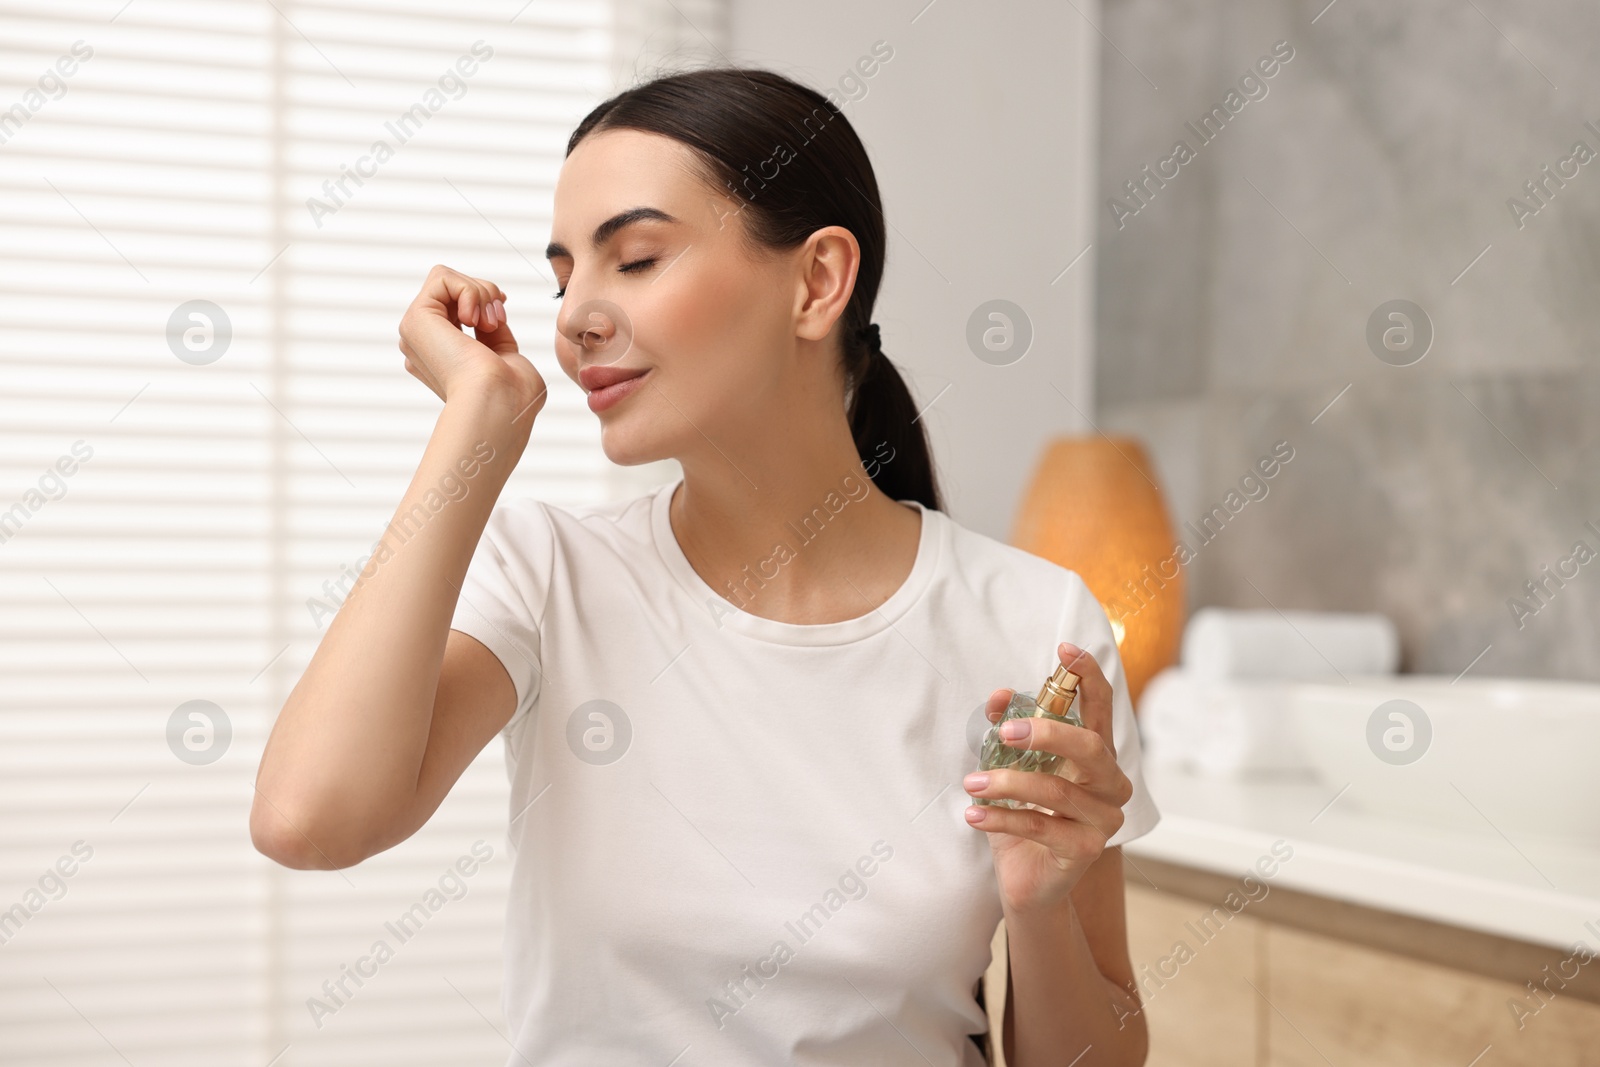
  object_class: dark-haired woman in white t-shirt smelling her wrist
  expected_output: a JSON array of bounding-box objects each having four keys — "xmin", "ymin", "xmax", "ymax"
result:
[{"xmin": 251, "ymin": 69, "xmax": 1157, "ymax": 1067}]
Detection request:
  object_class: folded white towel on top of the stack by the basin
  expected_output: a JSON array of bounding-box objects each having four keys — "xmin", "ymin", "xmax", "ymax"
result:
[{"xmin": 1182, "ymin": 608, "xmax": 1400, "ymax": 680}]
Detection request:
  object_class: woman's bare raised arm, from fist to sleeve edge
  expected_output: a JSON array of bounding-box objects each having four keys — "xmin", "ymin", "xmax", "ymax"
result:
[{"xmin": 250, "ymin": 267, "xmax": 546, "ymax": 869}]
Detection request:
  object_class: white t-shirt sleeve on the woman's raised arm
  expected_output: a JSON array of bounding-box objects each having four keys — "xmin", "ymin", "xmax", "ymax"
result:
[{"xmin": 450, "ymin": 499, "xmax": 555, "ymax": 726}]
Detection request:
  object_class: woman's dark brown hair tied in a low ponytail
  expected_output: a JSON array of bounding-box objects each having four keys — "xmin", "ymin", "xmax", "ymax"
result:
[{"xmin": 566, "ymin": 67, "xmax": 942, "ymax": 510}]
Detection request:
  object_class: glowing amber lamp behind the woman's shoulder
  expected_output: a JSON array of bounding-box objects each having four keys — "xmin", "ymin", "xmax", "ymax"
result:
[{"xmin": 1011, "ymin": 435, "xmax": 1186, "ymax": 707}]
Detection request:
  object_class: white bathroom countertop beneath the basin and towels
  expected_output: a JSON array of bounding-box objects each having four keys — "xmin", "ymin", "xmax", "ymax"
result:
[{"xmin": 1123, "ymin": 766, "xmax": 1600, "ymax": 949}]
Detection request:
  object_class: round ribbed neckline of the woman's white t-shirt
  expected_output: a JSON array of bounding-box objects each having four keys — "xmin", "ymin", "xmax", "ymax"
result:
[{"xmin": 650, "ymin": 477, "xmax": 944, "ymax": 645}]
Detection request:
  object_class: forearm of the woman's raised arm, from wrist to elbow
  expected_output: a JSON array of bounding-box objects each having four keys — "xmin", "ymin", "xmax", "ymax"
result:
[{"xmin": 251, "ymin": 390, "xmax": 531, "ymax": 867}]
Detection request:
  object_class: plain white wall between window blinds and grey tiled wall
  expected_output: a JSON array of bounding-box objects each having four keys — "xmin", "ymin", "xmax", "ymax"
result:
[{"xmin": 728, "ymin": 0, "xmax": 1099, "ymax": 539}]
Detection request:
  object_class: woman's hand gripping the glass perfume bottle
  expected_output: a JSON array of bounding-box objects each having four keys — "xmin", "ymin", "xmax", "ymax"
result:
[{"xmin": 963, "ymin": 643, "xmax": 1133, "ymax": 913}]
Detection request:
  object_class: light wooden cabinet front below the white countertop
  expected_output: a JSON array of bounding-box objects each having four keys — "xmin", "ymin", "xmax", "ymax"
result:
[{"xmin": 1030, "ymin": 885, "xmax": 1600, "ymax": 1067}]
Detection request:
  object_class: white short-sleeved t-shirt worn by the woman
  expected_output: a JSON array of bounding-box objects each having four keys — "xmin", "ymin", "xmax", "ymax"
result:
[{"xmin": 451, "ymin": 483, "xmax": 1160, "ymax": 1067}]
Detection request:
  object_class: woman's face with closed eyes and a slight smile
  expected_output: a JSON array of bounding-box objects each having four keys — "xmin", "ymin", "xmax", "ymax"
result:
[{"xmin": 547, "ymin": 130, "xmax": 803, "ymax": 466}]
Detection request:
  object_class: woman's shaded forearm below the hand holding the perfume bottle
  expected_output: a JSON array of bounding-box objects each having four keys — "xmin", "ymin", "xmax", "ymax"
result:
[{"xmin": 1005, "ymin": 901, "xmax": 1149, "ymax": 1067}]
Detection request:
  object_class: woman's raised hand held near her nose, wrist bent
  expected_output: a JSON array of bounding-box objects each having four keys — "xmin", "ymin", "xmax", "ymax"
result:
[{"xmin": 400, "ymin": 266, "xmax": 546, "ymax": 419}]
